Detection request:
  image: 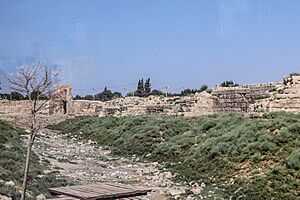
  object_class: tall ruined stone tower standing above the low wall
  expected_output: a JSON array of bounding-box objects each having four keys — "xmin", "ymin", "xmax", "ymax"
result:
[{"xmin": 49, "ymin": 85, "xmax": 73, "ymax": 115}]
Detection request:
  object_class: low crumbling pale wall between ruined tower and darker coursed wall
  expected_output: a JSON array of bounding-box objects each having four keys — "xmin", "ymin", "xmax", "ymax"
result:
[{"xmin": 70, "ymin": 92, "xmax": 213, "ymax": 116}]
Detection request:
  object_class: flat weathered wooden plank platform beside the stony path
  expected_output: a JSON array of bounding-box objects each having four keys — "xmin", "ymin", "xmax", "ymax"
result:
[{"xmin": 49, "ymin": 183, "xmax": 151, "ymax": 200}]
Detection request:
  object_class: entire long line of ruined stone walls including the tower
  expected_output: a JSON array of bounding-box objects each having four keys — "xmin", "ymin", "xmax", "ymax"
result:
[{"xmin": 0, "ymin": 76, "xmax": 300, "ymax": 117}]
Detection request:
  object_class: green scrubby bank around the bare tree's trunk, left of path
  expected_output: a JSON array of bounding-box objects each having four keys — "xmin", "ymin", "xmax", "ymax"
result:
[{"xmin": 0, "ymin": 121, "xmax": 69, "ymax": 199}]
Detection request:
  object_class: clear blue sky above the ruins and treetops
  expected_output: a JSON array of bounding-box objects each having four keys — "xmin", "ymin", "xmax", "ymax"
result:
[{"xmin": 0, "ymin": 0, "xmax": 300, "ymax": 94}]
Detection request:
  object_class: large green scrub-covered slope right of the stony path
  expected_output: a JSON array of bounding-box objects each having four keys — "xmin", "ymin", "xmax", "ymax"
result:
[{"xmin": 51, "ymin": 112, "xmax": 300, "ymax": 199}]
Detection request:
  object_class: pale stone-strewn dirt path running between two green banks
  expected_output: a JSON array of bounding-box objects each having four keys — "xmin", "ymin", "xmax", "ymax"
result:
[{"xmin": 33, "ymin": 129, "xmax": 201, "ymax": 200}]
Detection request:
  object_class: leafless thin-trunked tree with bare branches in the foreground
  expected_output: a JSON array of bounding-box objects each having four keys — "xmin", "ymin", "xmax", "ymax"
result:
[{"xmin": 7, "ymin": 62, "xmax": 58, "ymax": 200}]
